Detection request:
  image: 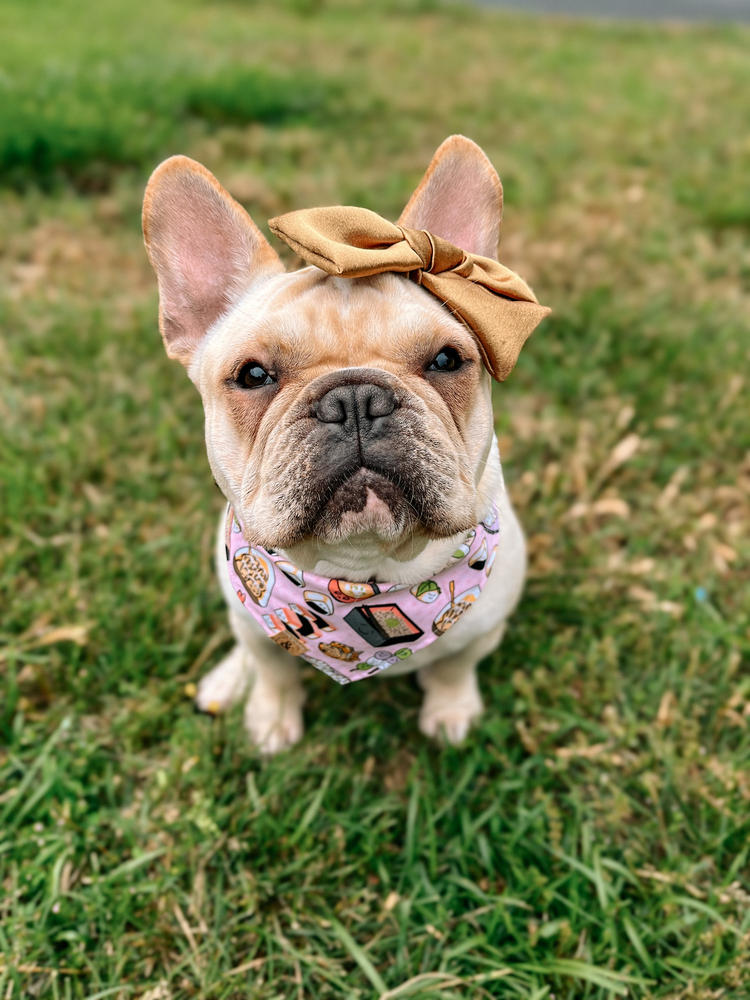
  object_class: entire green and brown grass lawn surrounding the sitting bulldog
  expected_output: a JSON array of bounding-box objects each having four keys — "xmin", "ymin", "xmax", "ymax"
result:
[{"xmin": 0, "ymin": 0, "xmax": 750, "ymax": 1000}]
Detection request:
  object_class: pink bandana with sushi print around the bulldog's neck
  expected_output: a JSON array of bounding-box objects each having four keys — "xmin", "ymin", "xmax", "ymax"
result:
[{"xmin": 226, "ymin": 507, "xmax": 500, "ymax": 684}]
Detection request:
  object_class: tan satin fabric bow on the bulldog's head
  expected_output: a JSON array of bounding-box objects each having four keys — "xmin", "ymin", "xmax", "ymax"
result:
[{"xmin": 268, "ymin": 205, "xmax": 550, "ymax": 381}]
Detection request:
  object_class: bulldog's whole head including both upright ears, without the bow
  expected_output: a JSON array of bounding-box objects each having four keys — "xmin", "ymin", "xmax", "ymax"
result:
[{"xmin": 144, "ymin": 138, "xmax": 502, "ymax": 548}]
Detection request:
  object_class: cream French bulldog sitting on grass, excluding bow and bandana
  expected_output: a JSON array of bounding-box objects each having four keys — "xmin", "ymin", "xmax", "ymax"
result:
[{"xmin": 143, "ymin": 136, "xmax": 547, "ymax": 753}]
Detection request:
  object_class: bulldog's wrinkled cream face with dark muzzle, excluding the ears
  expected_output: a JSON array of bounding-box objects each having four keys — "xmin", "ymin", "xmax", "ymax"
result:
[{"xmin": 197, "ymin": 268, "xmax": 491, "ymax": 547}]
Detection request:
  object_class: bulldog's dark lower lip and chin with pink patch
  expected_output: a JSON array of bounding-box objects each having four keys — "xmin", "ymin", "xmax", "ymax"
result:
[{"xmin": 311, "ymin": 468, "xmax": 417, "ymax": 543}]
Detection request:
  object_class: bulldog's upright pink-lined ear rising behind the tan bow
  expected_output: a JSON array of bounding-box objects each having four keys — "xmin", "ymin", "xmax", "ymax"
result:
[{"xmin": 398, "ymin": 135, "xmax": 503, "ymax": 257}]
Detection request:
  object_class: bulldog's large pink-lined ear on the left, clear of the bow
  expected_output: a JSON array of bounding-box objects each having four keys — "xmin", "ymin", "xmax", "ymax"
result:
[{"xmin": 143, "ymin": 156, "xmax": 284, "ymax": 365}]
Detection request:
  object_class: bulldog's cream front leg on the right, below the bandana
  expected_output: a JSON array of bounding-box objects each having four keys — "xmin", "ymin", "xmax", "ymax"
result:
[{"xmin": 417, "ymin": 622, "xmax": 505, "ymax": 743}]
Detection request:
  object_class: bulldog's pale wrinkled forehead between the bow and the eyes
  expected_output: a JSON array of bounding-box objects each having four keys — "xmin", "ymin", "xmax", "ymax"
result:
[{"xmin": 197, "ymin": 267, "xmax": 473, "ymax": 376}]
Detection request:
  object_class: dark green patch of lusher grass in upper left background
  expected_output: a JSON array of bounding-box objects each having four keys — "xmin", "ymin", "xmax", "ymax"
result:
[{"xmin": 0, "ymin": 63, "xmax": 340, "ymax": 191}]
